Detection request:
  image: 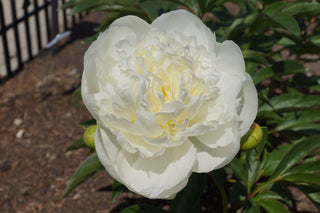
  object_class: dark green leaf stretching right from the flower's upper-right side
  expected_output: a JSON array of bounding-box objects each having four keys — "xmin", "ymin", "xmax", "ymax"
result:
[{"xmin": 252, "ymin": 60, "xmax": 306, "ymax": 84}]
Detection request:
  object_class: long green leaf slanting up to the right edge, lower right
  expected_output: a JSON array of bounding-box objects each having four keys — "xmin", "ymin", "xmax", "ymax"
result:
[{"xmin": 269, "ymin": 137, "xmax": 320, "ymax": 180}]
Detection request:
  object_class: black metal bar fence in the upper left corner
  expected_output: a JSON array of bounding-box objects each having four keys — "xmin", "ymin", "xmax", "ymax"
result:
[{"xmin": 0, "ymin": 0, "xmax": 82, "ymax": 83}]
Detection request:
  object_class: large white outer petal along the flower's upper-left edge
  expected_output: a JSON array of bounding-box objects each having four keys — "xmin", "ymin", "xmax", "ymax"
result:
[{"xmin": 81, "ymin": 16, "xmax": 151, "ymax": 119}]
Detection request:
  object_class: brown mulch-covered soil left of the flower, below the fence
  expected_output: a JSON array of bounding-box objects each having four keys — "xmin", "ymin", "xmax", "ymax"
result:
[{"xmin": 0, "ymin": 13, "xmax": 320, "ymax": 213}]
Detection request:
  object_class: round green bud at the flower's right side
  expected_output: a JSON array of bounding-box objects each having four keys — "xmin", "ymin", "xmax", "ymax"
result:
[{"xmin": 241, "ymin": 123, "xmax": 263, "ymax": 150}]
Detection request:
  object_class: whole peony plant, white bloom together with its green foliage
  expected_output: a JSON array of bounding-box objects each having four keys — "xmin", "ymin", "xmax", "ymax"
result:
[{"xmin": 63, "ymin": 0, "xmax": 320, "ymax": 213}]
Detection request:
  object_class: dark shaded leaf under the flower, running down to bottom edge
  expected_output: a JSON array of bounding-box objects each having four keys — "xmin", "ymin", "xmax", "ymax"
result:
[{"xmin": 169, "ymin": 173, "xmax": 207, "ymax": 213}]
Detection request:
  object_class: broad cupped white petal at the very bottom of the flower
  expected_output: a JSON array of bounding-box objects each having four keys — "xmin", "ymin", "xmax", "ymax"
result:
[{"xmin": 115, "ymin": 141, "xmax": 195, "ymax": 199}]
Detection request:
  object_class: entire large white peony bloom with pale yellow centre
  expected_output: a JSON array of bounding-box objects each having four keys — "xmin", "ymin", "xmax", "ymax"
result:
[{"xmin": 82, "ymin": 10, "xmax": 258, "ymax": 199}]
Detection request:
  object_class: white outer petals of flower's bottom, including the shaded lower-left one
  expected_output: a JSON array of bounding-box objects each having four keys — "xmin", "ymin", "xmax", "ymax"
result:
[{"xmin": 95, "ymin": 125, "xmax": 196, "ymax": 199}]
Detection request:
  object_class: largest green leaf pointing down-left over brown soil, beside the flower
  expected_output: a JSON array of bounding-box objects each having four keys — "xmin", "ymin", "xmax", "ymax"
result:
[{"xmin": 62, "ymin": 153, "xmax": 104, "ymax": 197}]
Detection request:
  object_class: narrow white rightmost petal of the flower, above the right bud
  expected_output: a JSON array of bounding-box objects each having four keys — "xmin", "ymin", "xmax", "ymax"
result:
[{"xmin": 240, "ymin": 74, "xmax": 258, "ymax": 136}]
